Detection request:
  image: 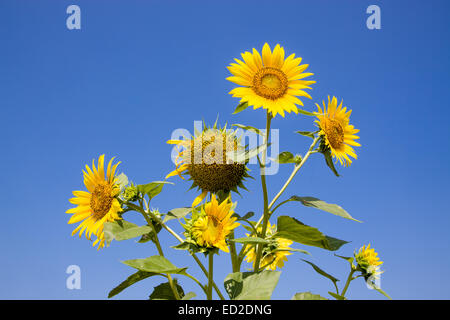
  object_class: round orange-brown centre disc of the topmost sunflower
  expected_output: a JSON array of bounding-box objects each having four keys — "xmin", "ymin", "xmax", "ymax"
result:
[{"xmin": 252, "ymin": 67, "xmax": 288, "ymax": 100}]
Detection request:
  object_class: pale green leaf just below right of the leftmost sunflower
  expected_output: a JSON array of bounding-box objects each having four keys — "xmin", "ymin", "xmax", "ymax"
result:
[{"xmin": 103, "ymin": 220, "xmax": 153, "ymax": 246}]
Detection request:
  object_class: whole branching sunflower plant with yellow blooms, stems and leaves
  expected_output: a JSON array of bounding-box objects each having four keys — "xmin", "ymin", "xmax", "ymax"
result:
[{"xmin": 67, "ymin": 43, "xmax": 389, "ymax": 300}]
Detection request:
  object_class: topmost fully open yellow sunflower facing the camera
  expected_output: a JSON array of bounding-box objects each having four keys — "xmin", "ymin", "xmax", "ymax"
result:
[{"xmin": 227, "ymin": 43, "xmax": 315, "ymax": 117}]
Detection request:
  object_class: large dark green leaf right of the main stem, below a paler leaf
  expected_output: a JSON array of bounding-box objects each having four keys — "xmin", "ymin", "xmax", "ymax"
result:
[{"xmin": 274, "ymin": 216, "xmax": 348, "ymax": 251}]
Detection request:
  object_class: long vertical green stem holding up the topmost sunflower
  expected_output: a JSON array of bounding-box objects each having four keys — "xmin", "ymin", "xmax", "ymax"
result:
[{"xmin": 254, "ymin": 111, "xmax": 272, "ymax": 272}]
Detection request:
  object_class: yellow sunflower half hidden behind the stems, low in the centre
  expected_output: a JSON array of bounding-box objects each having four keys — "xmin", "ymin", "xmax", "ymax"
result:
[{"xmin": 245, "ymin": 222, "xmax": 292, "ymax": 270}]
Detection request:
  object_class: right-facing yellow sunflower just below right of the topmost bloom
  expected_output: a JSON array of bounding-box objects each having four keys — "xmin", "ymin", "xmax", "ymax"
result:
[{"xmin": 315, "ymin": 96, "xmax": 361, "ymax": 167}]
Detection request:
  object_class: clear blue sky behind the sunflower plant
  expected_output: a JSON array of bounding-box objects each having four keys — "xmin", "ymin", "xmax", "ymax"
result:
[{"xmin": 0, "ymin": 0, "xmax": 450, "ymax": 299}]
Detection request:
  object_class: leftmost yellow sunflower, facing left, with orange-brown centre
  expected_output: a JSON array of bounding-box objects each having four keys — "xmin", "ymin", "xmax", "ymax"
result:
[{"xmin": 66, "ymin": 155, "xmax": 122, "ymax": 249}]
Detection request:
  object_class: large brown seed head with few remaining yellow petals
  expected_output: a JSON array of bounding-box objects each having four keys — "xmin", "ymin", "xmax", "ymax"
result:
[{"xmin": 166, "ymin": 128, "xmax": 249, "ymax": 206}]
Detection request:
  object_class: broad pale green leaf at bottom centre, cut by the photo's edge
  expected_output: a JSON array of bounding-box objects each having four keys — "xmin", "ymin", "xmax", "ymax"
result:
[{"xmin": 224, "ymin": 270, "xmax": 281, "ymax": 300}]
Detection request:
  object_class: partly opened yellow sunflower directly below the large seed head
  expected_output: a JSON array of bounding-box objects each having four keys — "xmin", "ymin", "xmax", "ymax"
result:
[{"xmin": 184, "ymin": 194, "xmax": 239, "ymax": 252}]
